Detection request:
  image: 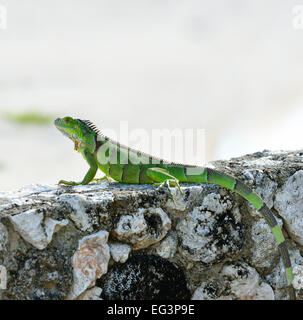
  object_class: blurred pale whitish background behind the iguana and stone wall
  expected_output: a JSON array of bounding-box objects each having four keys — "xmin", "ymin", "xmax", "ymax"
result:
[{"xmin": 0, "ymin": 0, "xmax": 303, "ymax": 191}]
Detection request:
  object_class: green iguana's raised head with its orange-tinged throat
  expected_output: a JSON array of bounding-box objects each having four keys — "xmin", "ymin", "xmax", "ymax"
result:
[{"xmin": 55, "ymin": 117, "xmax": 98, "ymax": 153}]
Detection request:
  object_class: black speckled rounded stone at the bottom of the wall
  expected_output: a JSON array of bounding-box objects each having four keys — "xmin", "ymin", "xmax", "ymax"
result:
[{"xmin": 96, "ymin": 254, "xmax": 190, "ymax": 300}]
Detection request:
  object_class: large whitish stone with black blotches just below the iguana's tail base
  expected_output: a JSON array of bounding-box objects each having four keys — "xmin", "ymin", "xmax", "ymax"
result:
[{"xmin": 176, "ymin": 193, "xmax": 244, "ymax": 263}]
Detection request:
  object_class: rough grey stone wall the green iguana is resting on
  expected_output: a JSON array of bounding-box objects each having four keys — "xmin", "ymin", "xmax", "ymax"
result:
[{"xmin": 0, "ymin": 151, "xmax": 303, "ymax": 300}]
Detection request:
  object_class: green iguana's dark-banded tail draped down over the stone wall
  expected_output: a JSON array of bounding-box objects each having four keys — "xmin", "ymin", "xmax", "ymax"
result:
[{"xmin": 188, "ymin": 168, "xmax": 296, "ymax": 300}]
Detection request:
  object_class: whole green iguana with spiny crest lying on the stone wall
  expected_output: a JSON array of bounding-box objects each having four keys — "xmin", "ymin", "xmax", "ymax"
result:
[{"xmin": 55, "ymin": 117, "xmax": 295, "ymax": 299}]
